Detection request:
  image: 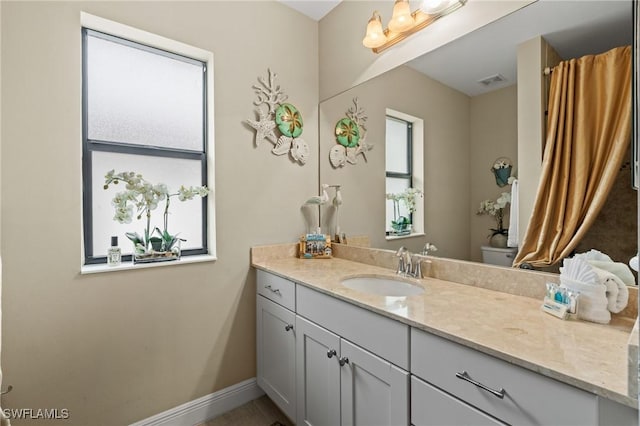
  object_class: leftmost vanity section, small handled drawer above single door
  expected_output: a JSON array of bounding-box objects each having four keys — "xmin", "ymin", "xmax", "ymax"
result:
[{"xmin": 256, "ymin": 271, "xmax": 296, "ymax": 419}]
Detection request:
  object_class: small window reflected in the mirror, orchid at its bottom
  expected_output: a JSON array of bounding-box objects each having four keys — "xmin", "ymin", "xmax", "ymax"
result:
[{"xmin": 385, "ymin": 109, "xmax": 424, "ymax": 236}]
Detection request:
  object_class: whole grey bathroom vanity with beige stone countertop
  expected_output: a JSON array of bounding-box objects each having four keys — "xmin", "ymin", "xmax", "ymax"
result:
[{"xmin": 252, "ymin": 245, "xmax": 638, "ymax": 425}]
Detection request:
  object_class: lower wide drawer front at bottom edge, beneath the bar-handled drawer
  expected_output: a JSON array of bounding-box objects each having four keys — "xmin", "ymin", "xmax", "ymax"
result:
[{"xmin": 411, "ymin": 376, "xmax": 505, "ymax": 426}]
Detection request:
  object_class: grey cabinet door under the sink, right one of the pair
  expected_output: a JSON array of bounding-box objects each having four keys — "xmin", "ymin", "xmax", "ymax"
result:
[{"xmin": 340, "ymin": 340, "xmax": 409, "ymax": 426}]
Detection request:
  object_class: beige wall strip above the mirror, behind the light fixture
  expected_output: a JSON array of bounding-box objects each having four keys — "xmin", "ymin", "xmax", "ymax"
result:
[{"xmin": 320, "ymin": 0, "xmax": 533, "ymax": 100}]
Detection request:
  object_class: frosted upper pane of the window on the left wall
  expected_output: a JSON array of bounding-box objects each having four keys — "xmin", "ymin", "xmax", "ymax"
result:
[{"xmin": 87, "ymin": 36, "xmax": 204, "ymax": 151}]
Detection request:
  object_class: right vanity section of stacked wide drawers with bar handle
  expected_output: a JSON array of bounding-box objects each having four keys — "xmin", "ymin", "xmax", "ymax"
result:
[{"xmin": 411, "ymin": 329, "xmax": 638, "ymax": 426}]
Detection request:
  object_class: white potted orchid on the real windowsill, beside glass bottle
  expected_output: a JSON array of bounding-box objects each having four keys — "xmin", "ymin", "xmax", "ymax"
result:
[{"xmin": 104, "ymin": 170, "xmax": 209, "ymax": 253}]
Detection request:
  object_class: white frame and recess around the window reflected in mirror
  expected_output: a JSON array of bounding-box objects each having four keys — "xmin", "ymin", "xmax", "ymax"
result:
[{"xmin": 385, "ymin": 108, "xmax": 426, "ymax": 241}]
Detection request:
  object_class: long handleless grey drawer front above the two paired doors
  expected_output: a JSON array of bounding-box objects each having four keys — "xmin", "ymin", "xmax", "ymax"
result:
[{"xmin": 296, "ymin": 285, "xmax": 409, "ymax": 370}]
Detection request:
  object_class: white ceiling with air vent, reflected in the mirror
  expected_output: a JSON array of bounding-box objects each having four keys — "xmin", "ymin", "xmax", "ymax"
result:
[{"xmin": 407, "ymin": 0, "xmax": 633, "ymax": 96}]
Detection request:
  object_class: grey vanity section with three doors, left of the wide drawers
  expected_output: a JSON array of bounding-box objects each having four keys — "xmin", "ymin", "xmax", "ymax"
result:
[{"xmin": 257, "ymin": 270, "xmax": 409, "ymax": 426}]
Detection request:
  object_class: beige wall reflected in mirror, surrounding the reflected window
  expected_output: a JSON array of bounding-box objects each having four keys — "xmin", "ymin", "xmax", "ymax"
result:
[{"xmin": 320, "ymin": 66, "xmax": 471, "ymax": 259}]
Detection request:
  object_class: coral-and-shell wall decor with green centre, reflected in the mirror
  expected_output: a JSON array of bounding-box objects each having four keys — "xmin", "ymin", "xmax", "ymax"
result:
[{"xmin": 329, "ymin": 98, "xmax": 373, "ymax": 169}]
